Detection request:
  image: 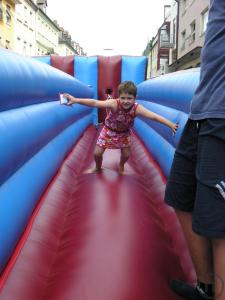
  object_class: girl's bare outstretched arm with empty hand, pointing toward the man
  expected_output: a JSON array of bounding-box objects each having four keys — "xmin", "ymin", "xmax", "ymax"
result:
[{"xmin": 136, "ymin": 104, "xmax": 179, "ymax": 134}]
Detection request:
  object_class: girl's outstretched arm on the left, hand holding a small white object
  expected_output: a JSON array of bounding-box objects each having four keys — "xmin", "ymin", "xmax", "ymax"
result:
[{"xmin": 63, "ymin": 93, "xmax": 117, "ymax": 109}]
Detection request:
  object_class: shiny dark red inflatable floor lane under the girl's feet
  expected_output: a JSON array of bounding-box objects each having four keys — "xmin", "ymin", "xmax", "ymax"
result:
[{"xmin": 0, "ymin": 128, "xmax": 194, "ymax": 300}]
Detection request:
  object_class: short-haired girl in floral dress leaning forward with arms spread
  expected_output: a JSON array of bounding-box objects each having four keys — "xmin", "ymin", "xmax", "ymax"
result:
[{"xmin": 63, "ymin": 81, "xmax": 178, "ymax": 174}]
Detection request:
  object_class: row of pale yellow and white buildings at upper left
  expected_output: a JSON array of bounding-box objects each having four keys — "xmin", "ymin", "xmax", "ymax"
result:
[{"xmin": 0, "ymin": 0, "xmax": 86, "ymax": 56}]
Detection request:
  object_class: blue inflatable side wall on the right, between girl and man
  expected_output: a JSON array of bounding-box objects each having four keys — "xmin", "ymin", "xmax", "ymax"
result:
[{"xmin": 134, "ymin": 69, "xmax": 199, "ymax": 177}]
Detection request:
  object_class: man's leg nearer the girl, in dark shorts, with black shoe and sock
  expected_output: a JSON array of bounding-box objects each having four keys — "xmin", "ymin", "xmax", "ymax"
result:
[{"xmin": 165, "ymin": 120, "xmax": 213, "ymax": 300}]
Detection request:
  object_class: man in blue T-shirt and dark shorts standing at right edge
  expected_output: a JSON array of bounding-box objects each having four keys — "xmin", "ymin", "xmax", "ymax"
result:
[{"xmin": 165, "ymin": 0, "xmax": 225, "ymax": 300}]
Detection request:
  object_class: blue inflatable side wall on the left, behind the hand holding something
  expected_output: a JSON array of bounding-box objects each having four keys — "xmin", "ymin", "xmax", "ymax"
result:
[{"xmin": 0, "ymin": 49, "xmax": 93, "ymax": 271}]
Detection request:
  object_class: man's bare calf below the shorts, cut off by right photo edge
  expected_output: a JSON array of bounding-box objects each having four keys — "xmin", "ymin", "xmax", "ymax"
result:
[{"xmin": 212, "ymin": 239, "xmax": 225, "ymax": 300}]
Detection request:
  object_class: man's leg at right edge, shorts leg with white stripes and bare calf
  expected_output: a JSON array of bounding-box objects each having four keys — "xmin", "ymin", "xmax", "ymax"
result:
[{"xmin": 192, "ymin": 119, "xmax": 225, "ymax": 300}]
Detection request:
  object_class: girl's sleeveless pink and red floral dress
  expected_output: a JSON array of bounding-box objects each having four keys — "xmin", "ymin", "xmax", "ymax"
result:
[{"xmin": 97, "ymin": 99, "xmax": 138, "ymax": 149}]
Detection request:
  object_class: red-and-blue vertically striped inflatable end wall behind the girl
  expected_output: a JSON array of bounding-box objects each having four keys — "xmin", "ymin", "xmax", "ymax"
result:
[{"xmin": 34, "ymin": 55, "xmax": 147, "ymax": 95}]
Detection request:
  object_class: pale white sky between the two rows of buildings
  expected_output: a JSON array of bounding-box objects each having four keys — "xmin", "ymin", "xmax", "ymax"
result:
[{"xmin": 46, "ymin": 0, "xmax": 171, "ymax": 56}]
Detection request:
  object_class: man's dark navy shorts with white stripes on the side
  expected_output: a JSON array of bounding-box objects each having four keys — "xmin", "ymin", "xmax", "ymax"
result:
[{"xmin": 165, "ymin": 119, "xmax": 225, "ymax": 238}]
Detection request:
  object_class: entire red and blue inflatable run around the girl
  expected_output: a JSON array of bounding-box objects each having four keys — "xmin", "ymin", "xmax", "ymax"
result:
[{"xmin": 0, "ymin": 49, "xmax": 199, "ymax": 300}]
